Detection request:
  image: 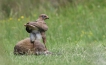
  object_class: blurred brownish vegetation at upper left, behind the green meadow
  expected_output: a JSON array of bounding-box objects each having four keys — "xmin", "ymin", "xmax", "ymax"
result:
[{"xmin": 0, "ymin": 0, "xmax": 73, "ymax": 18}]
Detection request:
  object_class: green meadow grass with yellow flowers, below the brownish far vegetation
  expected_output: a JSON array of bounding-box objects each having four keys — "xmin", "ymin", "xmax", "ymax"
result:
[{"xmin": 0, "ymin": 5, "xmax": 106, "ymax": 65}]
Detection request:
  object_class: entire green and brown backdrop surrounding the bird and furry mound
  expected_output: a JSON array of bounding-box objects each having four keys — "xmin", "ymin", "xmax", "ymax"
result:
[{"xmin": 0, "ymin": 0, "xmax": 106, "ymax": 65}]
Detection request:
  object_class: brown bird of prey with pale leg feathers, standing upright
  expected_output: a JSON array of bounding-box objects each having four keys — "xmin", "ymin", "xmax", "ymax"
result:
[{"xmin": 24, "ymin": 14, "xmax": 49, "ymax": 44}]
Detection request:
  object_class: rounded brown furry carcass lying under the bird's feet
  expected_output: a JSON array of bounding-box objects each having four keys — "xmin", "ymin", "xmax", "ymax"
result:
[{"xmin": 14, "ymin": 38, "xmax": 50, "ymax": 55}]
